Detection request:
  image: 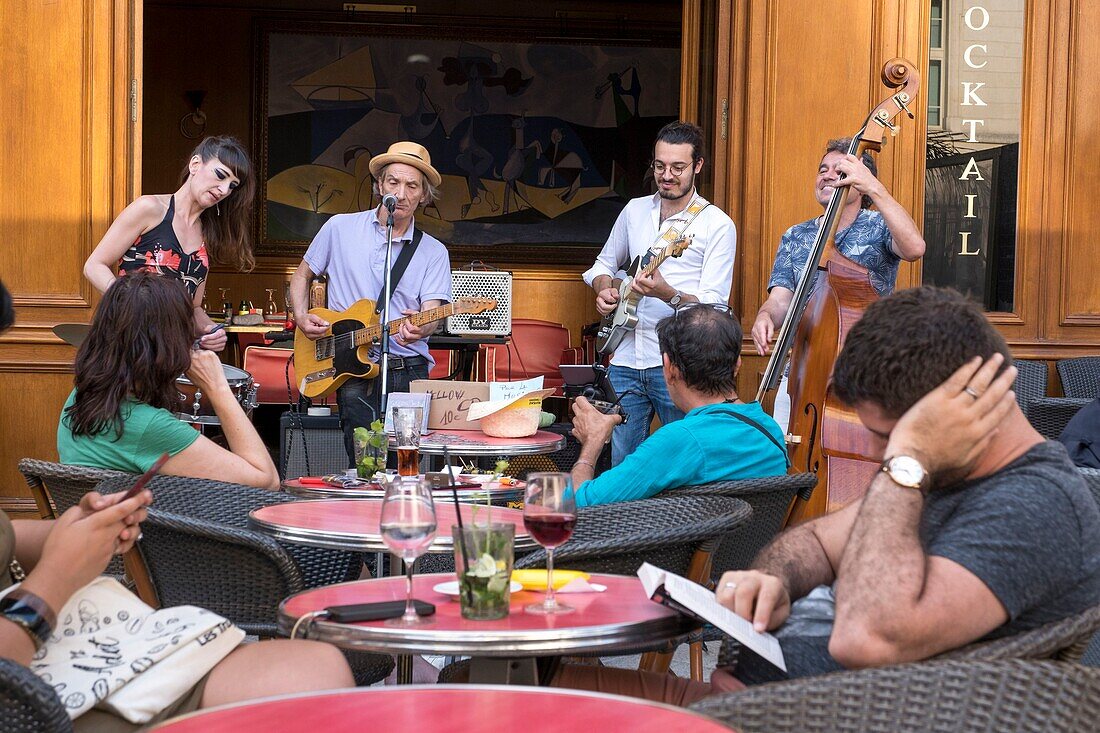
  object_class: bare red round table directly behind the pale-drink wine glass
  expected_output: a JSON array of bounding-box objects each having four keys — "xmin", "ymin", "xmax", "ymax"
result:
[{"xmin": 249, "ymin": 499, "xmax": 538, "ymax": 554}]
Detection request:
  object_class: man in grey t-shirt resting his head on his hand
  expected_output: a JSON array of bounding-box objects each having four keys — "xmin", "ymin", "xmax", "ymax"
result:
[{"xmin": 717, "ymin": 287, "xmax": 1100, "ymax": 682}]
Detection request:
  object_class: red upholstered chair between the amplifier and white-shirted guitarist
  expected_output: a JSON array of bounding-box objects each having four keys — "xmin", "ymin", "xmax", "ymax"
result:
[{"xmin": 475, "ymin": 318, "xmax": 584, "ymax": 396}]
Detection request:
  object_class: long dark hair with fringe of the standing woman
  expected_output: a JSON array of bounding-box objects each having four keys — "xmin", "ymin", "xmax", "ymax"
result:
[{"xmin": 179, "ymin": 135, "xmax": 256, "ymax": 272}]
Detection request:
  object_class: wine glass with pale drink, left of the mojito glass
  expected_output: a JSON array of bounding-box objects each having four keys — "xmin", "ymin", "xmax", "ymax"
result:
[{"xmin": 380, "ymin": 477, "xmax": 436, "ymax": 626}]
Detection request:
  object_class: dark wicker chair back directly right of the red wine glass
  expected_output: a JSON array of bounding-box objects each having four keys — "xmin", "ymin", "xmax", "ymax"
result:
[{"xmin": 516, "ymin": 495, "xmax": 752, "ymax": 580}]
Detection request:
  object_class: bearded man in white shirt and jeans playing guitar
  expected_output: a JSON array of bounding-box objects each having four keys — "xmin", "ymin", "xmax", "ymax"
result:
[{"xmin": 583, "ymin": 122, "xmax": 737, "ymax": 464}]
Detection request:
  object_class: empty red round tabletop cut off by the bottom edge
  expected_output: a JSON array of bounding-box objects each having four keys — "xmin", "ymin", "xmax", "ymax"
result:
[{"xmin": 146, "ymin": 685, "xmax": 729, "ymax": 733}]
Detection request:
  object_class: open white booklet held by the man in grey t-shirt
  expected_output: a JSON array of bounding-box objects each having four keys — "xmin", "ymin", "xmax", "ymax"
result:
[{"xmin": 638, "ymin": 562, "xmax": 787, "ymax": 671}]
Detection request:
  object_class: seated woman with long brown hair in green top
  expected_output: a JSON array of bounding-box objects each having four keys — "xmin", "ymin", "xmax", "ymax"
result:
[{"xmin": 57, "ymin": 272, "xmax": 279, "ymax": 490}]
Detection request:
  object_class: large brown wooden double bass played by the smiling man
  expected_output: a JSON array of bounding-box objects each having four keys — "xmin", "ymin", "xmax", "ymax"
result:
[{"xmin": 757, "ymin": 58, "xmax": 920, "ymax": 524}]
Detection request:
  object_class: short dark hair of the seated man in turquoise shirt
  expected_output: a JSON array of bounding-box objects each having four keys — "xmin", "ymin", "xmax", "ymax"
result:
[{"xmin": 657, "ymin": 304, "xmax": 745, "ymax": 395}]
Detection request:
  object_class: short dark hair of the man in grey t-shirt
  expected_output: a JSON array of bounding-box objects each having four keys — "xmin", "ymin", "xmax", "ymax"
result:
[{"xmin": 833, "ymin": 287, "xmax": 1012, "ymax": 417}]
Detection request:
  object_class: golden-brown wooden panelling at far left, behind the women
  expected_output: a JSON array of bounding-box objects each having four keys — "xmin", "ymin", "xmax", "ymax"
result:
[{"xmin": 0, "ymin": 0, "xmax": 141, "ymax": 514}]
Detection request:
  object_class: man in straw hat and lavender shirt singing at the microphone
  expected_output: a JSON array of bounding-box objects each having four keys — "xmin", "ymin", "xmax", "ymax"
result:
[{"xmin": 290, "ymin": 142, "xmax": 451, "ymax": 466}]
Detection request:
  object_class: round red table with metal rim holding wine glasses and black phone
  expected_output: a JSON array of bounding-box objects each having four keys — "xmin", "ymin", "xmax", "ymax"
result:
[{"xmin": 277, "ymin": 573, "xmax": 699, "ymax": 685}]
